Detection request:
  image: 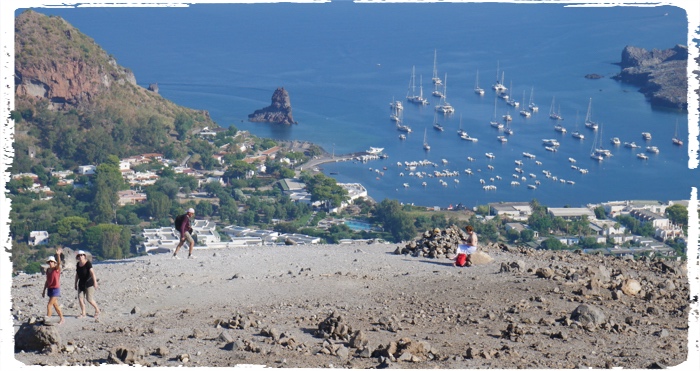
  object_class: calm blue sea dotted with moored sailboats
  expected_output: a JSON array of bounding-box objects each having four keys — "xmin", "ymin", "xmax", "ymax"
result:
[{"xmin": 24, "ymin": 1, "xmax": 700, "ymax": 207}]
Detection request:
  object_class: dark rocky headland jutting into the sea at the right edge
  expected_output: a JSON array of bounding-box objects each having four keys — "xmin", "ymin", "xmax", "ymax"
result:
[{"xmin": 613, "ymin": 45, "xmax": 688, "ymax": 110}]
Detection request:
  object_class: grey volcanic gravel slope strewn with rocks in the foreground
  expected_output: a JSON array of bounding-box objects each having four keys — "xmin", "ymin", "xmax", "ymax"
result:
[{"xmin": 11, "ymin": 241, "xmax": 694, "ymax": 369}]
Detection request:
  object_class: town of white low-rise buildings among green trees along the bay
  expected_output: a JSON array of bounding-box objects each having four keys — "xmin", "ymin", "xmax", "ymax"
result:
[{"xmin": 8, "ymin": 128, "xmax": 688, "ymax": 274}]
